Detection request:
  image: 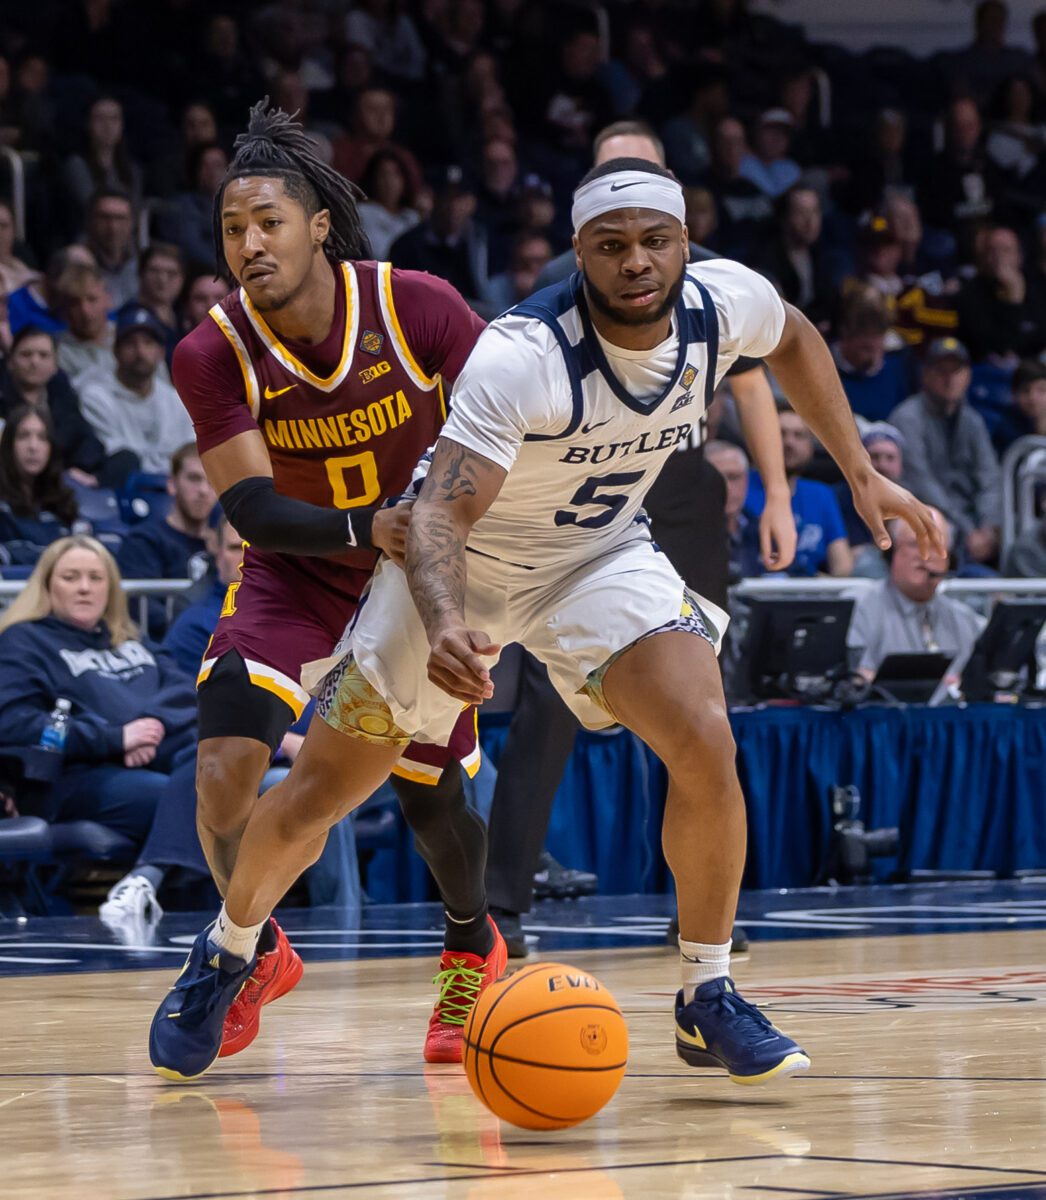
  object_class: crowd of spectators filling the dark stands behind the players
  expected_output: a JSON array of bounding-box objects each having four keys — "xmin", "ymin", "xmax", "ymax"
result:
[{"xmin": 0, "ymin": 0, "xmax": 1046, "ymax": 916}]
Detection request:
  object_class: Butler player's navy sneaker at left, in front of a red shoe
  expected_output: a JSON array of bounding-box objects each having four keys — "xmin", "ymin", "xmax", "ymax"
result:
[{"xmin": 149, "ymin": 925, "xmax": 256, "ymax": 1082}]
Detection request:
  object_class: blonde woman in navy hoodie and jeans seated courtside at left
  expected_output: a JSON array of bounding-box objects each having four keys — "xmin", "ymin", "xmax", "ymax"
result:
[{"xmin": 0, "ymin": 536, "xmax": 208, "ymax": 931}]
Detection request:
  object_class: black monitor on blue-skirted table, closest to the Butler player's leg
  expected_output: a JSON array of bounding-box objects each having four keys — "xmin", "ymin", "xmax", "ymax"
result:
[{"xmin": 746, "ymin": 600, "xmax": 854, "ymax": 701}]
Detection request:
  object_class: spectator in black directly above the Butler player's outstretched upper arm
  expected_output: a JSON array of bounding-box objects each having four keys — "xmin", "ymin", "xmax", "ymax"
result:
[{"xmin": 758, "ymin": 184, "xmax": 835, "ymax": 331}]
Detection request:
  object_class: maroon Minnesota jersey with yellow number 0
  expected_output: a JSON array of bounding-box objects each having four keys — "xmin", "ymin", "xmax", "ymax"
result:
[{"xmin": 174, "ymin": 262, "xmax": 482, "ymax": 598}]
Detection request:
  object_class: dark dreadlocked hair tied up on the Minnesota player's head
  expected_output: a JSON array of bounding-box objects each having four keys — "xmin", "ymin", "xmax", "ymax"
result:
[{"xmin": 211, "ymin": 96, "xmax": 371, "ymax": 276}]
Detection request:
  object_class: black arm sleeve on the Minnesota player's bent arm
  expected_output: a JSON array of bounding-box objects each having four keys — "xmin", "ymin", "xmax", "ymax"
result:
[{"xmin": 218, "ymin": 475, "xmax": 378, "ymax": 557}]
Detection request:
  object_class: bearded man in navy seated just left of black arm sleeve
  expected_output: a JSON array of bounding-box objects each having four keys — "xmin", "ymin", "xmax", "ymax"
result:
[{"xmin": 118, "ymin": 442, "xmax": 217, "ymax": 637}]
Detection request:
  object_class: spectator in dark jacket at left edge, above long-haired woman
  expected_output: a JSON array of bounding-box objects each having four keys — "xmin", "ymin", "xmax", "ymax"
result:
[{"xmin": 0, "ymin": 325, "xmax": 107, "ymax": 487}]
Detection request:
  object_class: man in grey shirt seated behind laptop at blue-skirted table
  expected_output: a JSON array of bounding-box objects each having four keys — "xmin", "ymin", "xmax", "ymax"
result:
[{"xmin": 847, "ymin": 510, "xmax": 984, "ymax": 684}]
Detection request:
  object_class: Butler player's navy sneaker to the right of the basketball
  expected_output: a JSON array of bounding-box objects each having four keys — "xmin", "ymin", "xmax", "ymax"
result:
[{"xmin": 675, "ymin": 978, "xmax": 810, "ymax": 1084}]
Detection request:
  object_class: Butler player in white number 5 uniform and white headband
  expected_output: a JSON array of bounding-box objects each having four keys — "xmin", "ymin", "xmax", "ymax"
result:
[{"xmin": 157, "ymin": 158, "xmax": 943, "ymax": 1084}]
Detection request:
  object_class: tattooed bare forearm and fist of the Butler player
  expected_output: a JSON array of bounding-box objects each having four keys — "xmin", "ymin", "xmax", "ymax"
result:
[{"xmin": 407, "ymin": 438, "xmax": 506, "ymax": 704}]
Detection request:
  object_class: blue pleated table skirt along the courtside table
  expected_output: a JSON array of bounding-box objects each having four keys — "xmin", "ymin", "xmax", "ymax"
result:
[{"xmin": 367, "ymin": 704, "xmax": 1046, "ymax": 900}]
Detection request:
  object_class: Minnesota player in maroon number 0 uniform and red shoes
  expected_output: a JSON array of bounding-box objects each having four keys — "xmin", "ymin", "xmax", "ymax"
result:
[{"xmin": 174, "ymin": 102, "xmax": 505, "ymax": 1062}]
